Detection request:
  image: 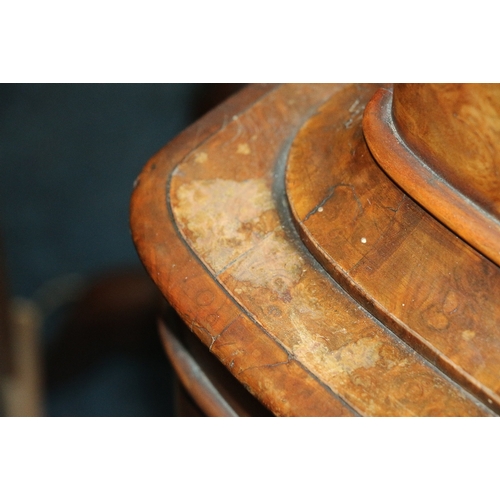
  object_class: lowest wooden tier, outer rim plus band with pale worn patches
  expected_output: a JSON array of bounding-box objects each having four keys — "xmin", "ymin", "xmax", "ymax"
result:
[{"xmin": 131, "ymin": 85, "xmax": 493, "ymax": 416}]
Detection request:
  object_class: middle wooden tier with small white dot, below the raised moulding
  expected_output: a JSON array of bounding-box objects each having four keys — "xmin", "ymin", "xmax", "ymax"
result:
[{"xmin": 287, "ymin": 86, "xmax": 500, "ymax": 411}]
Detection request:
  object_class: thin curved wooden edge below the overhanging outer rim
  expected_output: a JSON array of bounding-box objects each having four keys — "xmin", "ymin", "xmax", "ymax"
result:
[{"xmin": 158, "ymin": 321, "xmax": 239, "ymax": 417}]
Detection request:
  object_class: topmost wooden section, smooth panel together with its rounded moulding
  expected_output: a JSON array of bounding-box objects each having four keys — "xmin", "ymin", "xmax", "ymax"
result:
[{"xmin": 363, "ymin": 84, "xmax": 500, "ymax": 265}]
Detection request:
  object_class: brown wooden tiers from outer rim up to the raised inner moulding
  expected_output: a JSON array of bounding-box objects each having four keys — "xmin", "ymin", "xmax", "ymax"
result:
[{"xmin": 131, "ymin": 85, "xmax": 500, "ymax": 416}]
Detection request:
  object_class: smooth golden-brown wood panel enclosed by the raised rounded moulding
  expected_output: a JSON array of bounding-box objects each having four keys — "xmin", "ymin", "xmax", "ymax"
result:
[{"xmin": 391, "ymin": 83, "xmax": 500, "ymax": 219}]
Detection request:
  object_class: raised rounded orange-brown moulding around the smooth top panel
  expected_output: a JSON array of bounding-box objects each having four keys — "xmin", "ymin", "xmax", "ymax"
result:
[{"xmin": 363, "ymin": 88, "xmax": 500, "ymax": 265}]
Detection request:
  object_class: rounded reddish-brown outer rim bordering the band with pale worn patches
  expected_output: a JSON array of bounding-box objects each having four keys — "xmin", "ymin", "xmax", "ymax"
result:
[{"xmin": 130, "ymin": 85, "xmax": 356, "ymax": 416}]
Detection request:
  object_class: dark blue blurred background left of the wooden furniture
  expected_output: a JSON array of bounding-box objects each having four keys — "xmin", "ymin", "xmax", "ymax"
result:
[{"xmin": 0, "ymin": 84, "xmax": 236, "ymax": 415}]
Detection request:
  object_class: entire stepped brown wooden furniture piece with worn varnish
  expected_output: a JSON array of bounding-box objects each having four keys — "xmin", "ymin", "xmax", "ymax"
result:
[{"xmin": 131, "ymin": 84, "xmax": 500, "ymax": 416}]
